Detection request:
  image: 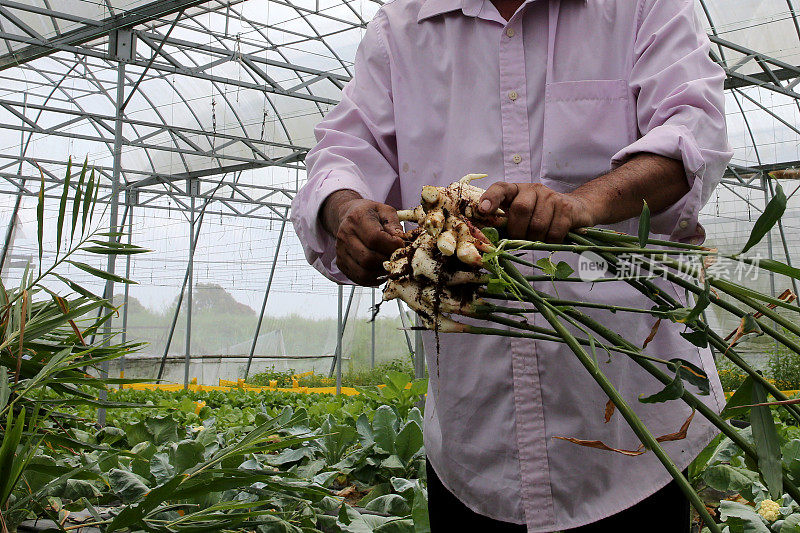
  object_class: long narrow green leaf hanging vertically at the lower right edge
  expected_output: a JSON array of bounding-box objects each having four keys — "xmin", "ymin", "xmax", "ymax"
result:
[{"xmin": 750, "ymin": 383, "xmax": 783, "ymax": 500}]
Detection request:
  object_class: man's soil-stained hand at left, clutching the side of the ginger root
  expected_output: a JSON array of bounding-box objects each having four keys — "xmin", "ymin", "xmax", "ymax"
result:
[{"xmin": 320, "ymin": 190, "xmax": 403, "ymax": 287}]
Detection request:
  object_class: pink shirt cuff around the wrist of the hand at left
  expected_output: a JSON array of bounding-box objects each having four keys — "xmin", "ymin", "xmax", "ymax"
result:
[{"xmin": 290, "ymin": 170, "xmax": 371, "ymax": 284}]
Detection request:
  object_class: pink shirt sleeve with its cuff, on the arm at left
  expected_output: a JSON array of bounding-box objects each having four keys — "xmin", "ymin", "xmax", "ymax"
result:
[{"xmin": 291, "ymin": 10, "xmax": 398, "ymax": 283}]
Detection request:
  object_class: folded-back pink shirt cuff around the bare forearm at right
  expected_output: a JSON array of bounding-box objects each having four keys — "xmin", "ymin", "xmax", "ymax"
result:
[{"xmin": 611, "ymin": 124, "xmax": 706, "ymax": 244}]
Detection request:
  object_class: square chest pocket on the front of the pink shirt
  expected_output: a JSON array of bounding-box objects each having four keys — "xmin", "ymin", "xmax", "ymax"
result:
[{"xmin": 541, "ymin": 80, "xmax": 636, "ymax": 192}]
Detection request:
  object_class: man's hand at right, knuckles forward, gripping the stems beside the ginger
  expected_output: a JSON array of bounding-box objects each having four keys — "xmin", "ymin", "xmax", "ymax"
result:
[{"xmin": 479, "ymin": 181, "xmax": 595, "ymax": 243}]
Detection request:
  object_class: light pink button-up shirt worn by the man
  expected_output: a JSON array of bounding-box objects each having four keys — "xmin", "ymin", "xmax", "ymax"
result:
[{"xmin": 292, "ymin": 0, "xmax": 731, "ymax": 531}]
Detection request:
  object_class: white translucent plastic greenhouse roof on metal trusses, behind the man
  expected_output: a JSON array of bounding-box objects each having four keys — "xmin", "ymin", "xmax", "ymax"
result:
[{"xmin": 0, "ymin": 0, "xmax": 800, "ymax": 183}]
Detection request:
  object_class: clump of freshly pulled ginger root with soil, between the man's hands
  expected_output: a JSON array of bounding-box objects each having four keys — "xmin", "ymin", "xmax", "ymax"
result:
[{"xmin": 383, "ymin": 174, "xmax": 505, "ymax": 332}]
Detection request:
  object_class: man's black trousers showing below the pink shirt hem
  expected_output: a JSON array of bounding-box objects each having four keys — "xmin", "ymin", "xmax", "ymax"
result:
[{"xmin": 427, "ymin": 463, "xmax": 690, "ymax": 533}]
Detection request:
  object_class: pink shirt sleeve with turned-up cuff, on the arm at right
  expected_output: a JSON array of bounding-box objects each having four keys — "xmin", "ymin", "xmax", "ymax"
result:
[{"xmin": 611, "ymin": 0, "xmax": 733, "ymax": 242}]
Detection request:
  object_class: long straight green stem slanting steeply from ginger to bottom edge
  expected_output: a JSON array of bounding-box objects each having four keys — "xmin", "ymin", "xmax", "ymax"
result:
[{"xmin": 500, "ymin": 260, "xmax": 721, "ymax": 533}]
